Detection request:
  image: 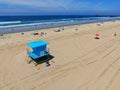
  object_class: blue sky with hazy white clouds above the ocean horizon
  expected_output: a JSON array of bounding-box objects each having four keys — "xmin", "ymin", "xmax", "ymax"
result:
[{"xmin": 0, "ymin": 0, "xmax": 120, "ymax": 15}]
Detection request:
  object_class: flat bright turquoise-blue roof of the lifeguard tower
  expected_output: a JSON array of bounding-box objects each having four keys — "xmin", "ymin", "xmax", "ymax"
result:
[{"xmin": 27, "ymin": 40, "xmax": 48, "ymax": 48}]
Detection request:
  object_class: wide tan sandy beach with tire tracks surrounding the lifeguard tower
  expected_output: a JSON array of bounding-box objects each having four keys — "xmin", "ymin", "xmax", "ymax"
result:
[{"xmin": 0, "ymin": 21, "xmax": 120, "ymax": 90}]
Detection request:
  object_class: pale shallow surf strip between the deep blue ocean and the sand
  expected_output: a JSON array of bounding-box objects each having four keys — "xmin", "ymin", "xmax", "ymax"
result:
[{"xmin": 0, "ymin": 19, "xmax": 119, "ymax": 34}]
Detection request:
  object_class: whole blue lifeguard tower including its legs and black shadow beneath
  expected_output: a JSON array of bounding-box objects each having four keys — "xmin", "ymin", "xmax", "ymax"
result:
[{"xmin": 27, "ymin": 40, "xmax": 54, "ymax": 66}]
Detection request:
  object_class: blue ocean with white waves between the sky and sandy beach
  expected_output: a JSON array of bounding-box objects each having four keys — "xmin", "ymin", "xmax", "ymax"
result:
[{"xmin": 0, "ymin": 15, "xmax": 120, "ymax": 34}]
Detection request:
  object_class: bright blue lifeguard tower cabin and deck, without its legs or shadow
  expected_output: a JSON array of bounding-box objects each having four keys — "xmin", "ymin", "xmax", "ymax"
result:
[{"xmin": 27, "ymin": 40, "xmax": 49, "ymax": 59}]
